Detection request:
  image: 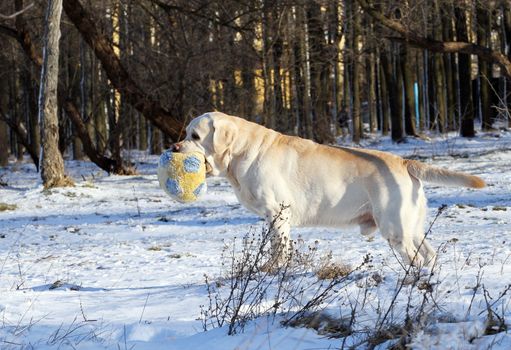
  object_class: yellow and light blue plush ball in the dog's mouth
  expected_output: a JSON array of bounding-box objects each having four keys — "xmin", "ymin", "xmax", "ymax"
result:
[{"xmin": 158, "ymin": 150, "xmax": 207, "ymax": 203}]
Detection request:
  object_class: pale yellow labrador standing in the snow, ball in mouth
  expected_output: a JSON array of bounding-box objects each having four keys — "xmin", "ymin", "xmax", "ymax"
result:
[{"xmin": 174, "ymin": 112, "xmax": 485, "ymax": 265}]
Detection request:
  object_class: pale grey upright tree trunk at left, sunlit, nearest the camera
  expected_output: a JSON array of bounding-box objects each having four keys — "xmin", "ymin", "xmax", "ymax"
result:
[{"xmin": 39, "ymin": 0, "xmax": 72, "ymax": 188}]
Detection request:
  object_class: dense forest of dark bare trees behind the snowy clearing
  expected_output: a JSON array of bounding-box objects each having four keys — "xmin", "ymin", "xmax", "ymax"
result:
[{"xmin": 0, "ymin": 0, "xmax": 511, "ymax": 180}]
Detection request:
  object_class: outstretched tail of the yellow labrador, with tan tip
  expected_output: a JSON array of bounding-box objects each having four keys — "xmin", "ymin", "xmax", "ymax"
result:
[{"xmin": 405, "ymin": 159, "xmax": 486, "ymax": 188}]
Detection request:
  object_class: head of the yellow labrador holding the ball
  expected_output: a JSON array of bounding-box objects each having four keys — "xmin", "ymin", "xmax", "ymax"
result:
[{"xmin": 174, "ymin": 112, "xmax": 237, "ymax": 176}]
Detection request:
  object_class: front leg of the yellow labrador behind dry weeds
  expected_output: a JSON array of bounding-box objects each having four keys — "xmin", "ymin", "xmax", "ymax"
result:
[{"xmin": 263, "ymin": 206, "xmax": 293, "ymax": 271}]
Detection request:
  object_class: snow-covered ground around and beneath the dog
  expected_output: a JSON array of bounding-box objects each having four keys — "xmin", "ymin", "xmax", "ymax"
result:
[{"xmin": 0, "ymin": 132, "xmax": 511, "ymax": 349}]
